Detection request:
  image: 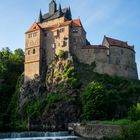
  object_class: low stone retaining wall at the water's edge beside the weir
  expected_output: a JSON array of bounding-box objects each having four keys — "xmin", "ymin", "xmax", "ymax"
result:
[{"xmin": 69, "ymin": 124, "xmax": 121, "ymax": 140}]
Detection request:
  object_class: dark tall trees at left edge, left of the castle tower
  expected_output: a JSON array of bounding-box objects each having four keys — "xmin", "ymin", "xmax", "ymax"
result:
[{"xmin": 0, "ymin": 47, "xmax": 24, "ymax": 130}]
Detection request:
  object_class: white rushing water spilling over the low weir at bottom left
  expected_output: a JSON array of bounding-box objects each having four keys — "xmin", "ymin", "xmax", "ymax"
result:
[{"xmin": 0, "ymin": 132, "xmax": 80, "ymax": 140}]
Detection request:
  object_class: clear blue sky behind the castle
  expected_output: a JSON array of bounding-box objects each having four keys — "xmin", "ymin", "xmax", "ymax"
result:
[{"xmin": 0, "ymin": 0, "xmax": 140, "ymax": 77}]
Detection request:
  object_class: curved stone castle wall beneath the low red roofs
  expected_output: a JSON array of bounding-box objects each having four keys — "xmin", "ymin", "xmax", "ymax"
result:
[{"xmin": 76, "ymin": 46, "xmax": 138, "ymax": 79}]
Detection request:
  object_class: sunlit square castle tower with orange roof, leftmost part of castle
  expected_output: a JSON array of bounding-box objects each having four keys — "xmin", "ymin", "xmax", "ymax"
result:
[{"xmin": 24, "ymin": 23, "xmax": 42, "ymax": 81}]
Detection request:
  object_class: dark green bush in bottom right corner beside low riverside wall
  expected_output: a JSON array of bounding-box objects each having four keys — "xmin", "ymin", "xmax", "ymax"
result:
[{"xmin": 122, "ymin": 121, "xmax": 140, "ymax": 140}]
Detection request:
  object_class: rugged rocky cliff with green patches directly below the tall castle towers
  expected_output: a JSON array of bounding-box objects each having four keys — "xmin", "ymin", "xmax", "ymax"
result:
[{"xmin": 18, "ymin": 60, "xmax": 81, "ymax": 129}]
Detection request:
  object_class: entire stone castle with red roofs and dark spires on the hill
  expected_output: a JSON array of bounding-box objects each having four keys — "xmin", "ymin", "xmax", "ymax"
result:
[{"xmin": 25, "ymin": 0, "xmax": 138, "ymax": 81}]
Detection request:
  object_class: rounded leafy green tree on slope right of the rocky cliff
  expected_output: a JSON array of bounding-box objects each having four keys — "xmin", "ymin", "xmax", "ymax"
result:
[{"xmin": 81, "ymin": 82, "xmax": 106, "ymax": 120}]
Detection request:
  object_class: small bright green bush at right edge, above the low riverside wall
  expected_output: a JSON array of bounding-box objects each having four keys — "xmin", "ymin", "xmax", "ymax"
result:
[{"xmin": 128, "ymin": 103, "xmax": 140, "ymax": 121}]
